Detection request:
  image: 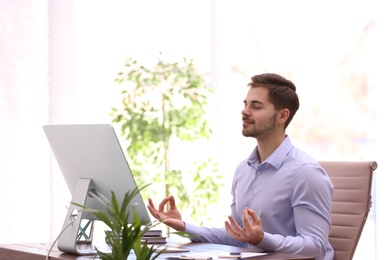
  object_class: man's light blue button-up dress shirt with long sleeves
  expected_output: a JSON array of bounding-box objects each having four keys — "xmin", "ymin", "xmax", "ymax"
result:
[{"xmin": 185, "ymin": 136, "xmax": 334, "ymax": 260}]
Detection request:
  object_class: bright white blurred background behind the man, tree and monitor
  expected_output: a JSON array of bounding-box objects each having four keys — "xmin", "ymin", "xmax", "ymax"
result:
[{"xmin": 0, "ymin": 0, "xmax": 390, "ymax": 259}]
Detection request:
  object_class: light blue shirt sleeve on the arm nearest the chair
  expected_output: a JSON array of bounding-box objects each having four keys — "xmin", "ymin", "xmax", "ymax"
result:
[{"xmin": 258, "ymin": 164, "xmax": 333, "ymax": 259}]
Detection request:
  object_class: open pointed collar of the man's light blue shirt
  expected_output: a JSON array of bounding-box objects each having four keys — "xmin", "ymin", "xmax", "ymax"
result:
[{"xmin": 247, "ymin": 136, "xmax": 292, "ymax": 169}]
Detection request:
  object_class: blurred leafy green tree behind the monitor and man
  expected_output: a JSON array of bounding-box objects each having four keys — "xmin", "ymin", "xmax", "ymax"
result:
[{"xmin": 111, "ymin": 55, "xmax": 221, "ymax": 224}]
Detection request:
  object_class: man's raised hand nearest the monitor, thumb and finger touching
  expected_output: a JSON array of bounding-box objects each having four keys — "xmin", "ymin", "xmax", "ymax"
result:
[{"xmin": 148, "ymin": 195, "xmax": 185, "ymax": 231}]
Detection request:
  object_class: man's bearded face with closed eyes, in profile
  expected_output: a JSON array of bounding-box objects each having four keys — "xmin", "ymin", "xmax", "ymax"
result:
[{"xmin": 241, "ymin": 87, "xmax": 277, "ymax": 138}]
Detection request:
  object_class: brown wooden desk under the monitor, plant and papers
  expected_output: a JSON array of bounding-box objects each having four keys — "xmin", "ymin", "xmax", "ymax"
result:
[{"xmin": 0, "ymin": 240, "xmax": 314, "ymax": 260}]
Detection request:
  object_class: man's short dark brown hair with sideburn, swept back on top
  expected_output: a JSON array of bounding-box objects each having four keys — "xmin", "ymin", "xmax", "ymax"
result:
[{"xmin": 248, "ymin": 73, "xmax": 299, "ymax": 128}]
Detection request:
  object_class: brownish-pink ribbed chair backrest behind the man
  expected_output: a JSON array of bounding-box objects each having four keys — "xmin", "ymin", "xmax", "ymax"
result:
[{"xmin": 319, "ymin": 161, "xmax": 378, "ymax": 260}]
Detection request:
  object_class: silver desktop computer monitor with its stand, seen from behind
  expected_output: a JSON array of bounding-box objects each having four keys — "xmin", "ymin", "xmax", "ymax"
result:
[{"xmin": 43, "ymin": 124, "xmax": 151, "ymax": 255}]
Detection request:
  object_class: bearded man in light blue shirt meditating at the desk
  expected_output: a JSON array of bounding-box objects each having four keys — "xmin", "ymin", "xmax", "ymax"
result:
[{"xmin": 148, "ymin": 73, "xmax": 334, "ymax": 260}]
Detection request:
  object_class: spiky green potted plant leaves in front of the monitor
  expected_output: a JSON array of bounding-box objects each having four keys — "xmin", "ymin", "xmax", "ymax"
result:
[{"xmin": 75, "ymin": 186, "xmax": 161, "ymax": 260}]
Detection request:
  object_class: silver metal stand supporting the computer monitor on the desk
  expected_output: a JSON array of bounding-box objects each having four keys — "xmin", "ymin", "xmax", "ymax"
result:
[{"xmin": 57, "ymin": 178, "xmax": 97, "ymax": 255}]
